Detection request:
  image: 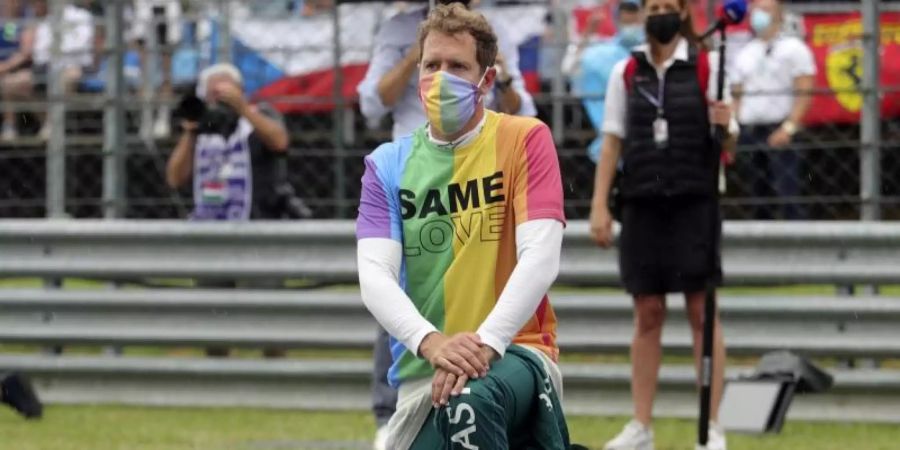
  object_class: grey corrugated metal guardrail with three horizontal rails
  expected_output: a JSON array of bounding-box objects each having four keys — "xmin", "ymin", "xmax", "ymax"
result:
[{"xmin": 0, "ymin": 220, "xmax": 900, "ymax": 423}]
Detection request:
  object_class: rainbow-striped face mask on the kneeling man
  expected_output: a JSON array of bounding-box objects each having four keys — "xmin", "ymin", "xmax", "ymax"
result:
[{"xmin": 419, "ymin": 71, "xmax": 487, "ymax": 135}]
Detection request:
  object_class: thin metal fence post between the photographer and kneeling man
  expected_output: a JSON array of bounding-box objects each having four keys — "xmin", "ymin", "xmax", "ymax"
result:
[{"xmin": 332, "ymin": 3, "xmax": 347, "ymax": 217}]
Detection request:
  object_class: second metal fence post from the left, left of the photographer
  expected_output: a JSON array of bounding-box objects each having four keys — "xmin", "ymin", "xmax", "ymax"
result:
[{"xmin": 103, "ymin": 0, "xmax": 126, "ymax": 219}]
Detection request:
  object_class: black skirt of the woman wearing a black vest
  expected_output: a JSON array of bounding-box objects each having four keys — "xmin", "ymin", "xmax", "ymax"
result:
[{"xmin": 619, "ymin": 197, "xmax": 722, "ymax": 295}]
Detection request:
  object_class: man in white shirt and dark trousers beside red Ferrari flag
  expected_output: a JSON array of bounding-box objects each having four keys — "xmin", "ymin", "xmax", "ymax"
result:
[{"xmin": 732, "ymin": 0, "xmax": 816, "ymax": 220}]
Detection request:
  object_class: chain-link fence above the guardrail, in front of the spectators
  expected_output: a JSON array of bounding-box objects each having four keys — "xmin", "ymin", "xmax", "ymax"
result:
[{"xmin": 0, "ymin": 0, "xmax": 900, "ymax": 220}]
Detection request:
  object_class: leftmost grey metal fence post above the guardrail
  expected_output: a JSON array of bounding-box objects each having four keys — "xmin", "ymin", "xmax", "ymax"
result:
[{"xmin": 46, "ymin": 1, "xmax": 66, "ymax": 218}]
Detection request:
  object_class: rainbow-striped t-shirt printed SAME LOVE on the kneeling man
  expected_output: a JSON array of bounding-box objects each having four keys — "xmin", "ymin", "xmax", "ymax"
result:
[{"xmin": 357, "ymin": 111, "xmax": 565, "ymax": 385}]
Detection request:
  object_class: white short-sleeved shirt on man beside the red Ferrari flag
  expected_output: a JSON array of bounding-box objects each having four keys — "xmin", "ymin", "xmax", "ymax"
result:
[{"xmin": 732, "ymin": 36, "xmax": 816, "ymax": 125}]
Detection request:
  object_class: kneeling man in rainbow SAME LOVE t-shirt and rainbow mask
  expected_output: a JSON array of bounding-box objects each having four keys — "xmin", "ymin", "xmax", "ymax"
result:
[{"xmin": 357, "ymin": 4, "xmax": 569, "ymax": 450}]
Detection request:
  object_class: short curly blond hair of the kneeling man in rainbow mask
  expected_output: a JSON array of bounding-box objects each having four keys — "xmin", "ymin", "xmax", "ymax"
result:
[{"xmin": 419, "ymin": 2, "xmax": 497, "ymax": 70}]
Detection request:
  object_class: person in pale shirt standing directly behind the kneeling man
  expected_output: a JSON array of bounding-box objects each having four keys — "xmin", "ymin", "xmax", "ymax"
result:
[{"xmin": 357, "ymin": 0, "xmax": 537, "ymax": 449}]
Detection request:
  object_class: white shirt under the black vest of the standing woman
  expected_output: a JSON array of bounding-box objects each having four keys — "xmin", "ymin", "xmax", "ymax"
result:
[{"xmin": 603, "ymin": 38, "xmax": 740, "ymax": 139}]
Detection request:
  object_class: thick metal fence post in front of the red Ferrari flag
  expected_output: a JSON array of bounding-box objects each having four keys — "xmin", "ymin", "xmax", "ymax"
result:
[{"xmin": 859, "ymin": 0, "xmax": 881, "ymax": 220}]
